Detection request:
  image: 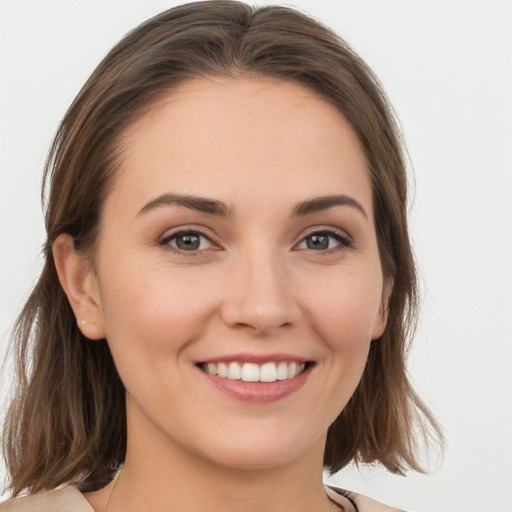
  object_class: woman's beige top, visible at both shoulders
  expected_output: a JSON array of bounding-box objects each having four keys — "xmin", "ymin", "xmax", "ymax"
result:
[{"xmin": 0, "ymin": 485, "xmax": 403, "ymax": 512}]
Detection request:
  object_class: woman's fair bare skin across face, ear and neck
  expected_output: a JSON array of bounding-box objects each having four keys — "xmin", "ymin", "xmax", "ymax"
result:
[{"xmin": 54, "ymin": 78, "xmax": 386, "ymax": 512}]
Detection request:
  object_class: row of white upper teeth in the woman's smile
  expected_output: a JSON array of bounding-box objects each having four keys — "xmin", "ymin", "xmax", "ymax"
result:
[{"xmin": 203, "ymin": 361, "xmax": 306, "ymax": 382}]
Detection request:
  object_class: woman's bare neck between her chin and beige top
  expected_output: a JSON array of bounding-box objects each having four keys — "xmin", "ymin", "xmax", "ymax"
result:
[{"xmin": 99, "ymin": 420, "xmax": 332, "ymax": 512}]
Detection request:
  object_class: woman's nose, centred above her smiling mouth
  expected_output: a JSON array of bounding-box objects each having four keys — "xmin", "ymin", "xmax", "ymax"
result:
[{"xmin": 221, "ymin": 252, "xmax": 302, "ymax": 336}]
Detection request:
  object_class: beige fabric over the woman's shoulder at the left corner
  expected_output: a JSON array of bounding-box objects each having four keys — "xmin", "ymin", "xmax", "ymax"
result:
[{"xmin": 0, "ymin": 485, "xmax": 94, "ymax": 512}]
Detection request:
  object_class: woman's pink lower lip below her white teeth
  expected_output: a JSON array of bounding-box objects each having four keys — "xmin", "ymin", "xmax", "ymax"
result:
[{"xmin": 199, "ymin": 365, "xmax": 313, "ymax": 403}]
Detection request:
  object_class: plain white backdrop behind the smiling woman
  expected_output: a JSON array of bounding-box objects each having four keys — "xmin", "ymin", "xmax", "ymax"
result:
[{"xmin": 0, "ymin": 0, "xmax": 512, "ymax": 512}]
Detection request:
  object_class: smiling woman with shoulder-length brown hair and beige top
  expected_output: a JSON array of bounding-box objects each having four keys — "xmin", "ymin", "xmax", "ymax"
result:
[{"xmin": 0, "ymin": 0, "xmax": 437, "ymax": 512}]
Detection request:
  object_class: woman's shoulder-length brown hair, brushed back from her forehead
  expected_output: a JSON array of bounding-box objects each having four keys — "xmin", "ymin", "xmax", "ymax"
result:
[{"xmin": 4, "ymin": 0, "xmax": 439, "ymax": 495}]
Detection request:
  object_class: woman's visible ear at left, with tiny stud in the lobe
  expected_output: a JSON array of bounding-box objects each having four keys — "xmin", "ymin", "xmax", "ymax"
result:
[{"xmin": 52, "ymin": 234, "xmax": 106, "ymax": 340}]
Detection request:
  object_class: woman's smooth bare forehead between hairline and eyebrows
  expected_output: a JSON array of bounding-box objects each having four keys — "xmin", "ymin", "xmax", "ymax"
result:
[{"xmin": 109, "ymin": 78, "xmax": 371, "ymax": 217}]
